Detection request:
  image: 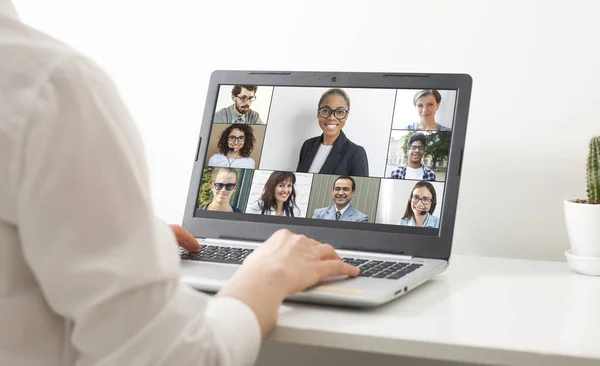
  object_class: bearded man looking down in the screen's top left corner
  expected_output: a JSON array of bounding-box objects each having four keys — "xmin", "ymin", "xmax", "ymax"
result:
[{"xmin": 214, "ymin": 85, "xmax": 264, "ymax": 124}]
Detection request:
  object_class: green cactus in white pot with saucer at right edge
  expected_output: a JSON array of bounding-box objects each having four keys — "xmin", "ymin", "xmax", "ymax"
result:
[{"xmin": 564, "ymin": 136, "xmax": 600, "ymax": 275}]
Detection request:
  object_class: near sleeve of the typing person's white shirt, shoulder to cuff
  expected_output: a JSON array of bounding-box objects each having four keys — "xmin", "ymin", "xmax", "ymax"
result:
[{"xmin": 17, "ymin": 56, "xmax": 261, "ymax": 366}]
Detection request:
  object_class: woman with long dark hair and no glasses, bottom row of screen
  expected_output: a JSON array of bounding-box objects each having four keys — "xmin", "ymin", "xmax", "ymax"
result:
[{"xmin": 247, "ymin": 171, "xmax": 301, "ymax": 217}]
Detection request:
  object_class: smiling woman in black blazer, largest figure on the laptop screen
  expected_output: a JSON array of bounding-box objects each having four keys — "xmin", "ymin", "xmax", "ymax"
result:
[{"xmin": 296, "ymin": 89, "xmax": 369, "ymax": 177}]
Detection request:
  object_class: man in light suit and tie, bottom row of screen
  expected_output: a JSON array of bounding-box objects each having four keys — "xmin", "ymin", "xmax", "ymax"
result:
[{"xmin": 313, "ymin": 176, "xmax": 369, "ymax": 222}]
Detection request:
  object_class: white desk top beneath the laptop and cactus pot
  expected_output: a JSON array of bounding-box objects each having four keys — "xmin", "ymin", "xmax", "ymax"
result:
[{"xmin": 259, "ymin": 255, "xmax": 600, "ymax": 366}]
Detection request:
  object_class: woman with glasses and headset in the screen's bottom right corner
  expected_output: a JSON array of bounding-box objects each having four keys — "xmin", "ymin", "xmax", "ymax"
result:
[{"xmin": 398, "ymin": 181, "xmax": 440, "ymax": 228}]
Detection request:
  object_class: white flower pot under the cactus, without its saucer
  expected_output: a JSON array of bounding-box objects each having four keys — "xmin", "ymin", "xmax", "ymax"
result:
[{"xmin": 564, "ymin": 200, "xmax": 600, "ymax": 258}]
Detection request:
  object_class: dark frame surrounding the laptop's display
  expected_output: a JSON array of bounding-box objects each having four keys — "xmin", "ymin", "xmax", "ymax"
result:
[{"xmin": 182, "ymin": 70, "xmax": 472, "ymax": 260}]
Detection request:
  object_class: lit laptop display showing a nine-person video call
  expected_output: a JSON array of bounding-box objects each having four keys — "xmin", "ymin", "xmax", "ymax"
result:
[{"xmin": 194, "ymin": 85, "xmax": 457, "ymax": 235}]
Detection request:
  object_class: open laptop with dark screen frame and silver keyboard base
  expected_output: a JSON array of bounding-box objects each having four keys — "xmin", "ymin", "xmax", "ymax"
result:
[{"xmin": 180, "ymin": 70, "xmax": 472, "ymax": 307}]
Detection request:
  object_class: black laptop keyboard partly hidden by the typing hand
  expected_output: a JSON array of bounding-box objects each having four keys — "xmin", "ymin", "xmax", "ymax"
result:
[{"xmin": 179, "ymin": 245, "xmax": 421, "ymax": 280}]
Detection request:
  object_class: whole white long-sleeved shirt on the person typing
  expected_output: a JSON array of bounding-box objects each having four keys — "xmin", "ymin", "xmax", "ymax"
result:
[{"xmin": 0, "ymin": 0, "xmax": 261, "ymax": 366}]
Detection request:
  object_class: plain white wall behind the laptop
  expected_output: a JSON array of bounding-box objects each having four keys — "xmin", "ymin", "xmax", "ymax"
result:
[{"xmin": 16, "ymin": 0, "xmax": 600, "ymax": 260}]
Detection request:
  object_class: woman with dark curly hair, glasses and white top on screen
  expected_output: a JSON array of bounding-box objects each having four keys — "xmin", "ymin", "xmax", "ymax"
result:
[{"xmin": 208, "ymin": 124, "xmax": 256, "ymax": 169}]
